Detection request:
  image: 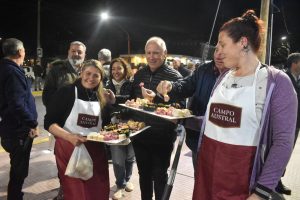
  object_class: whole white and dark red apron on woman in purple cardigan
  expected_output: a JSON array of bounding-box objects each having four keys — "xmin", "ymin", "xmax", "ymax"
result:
[{"xmin": 193, "ymin": 67, "xmax": 259, "ymax": 200}]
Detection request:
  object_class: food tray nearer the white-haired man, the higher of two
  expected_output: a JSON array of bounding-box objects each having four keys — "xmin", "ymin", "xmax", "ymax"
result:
[{"xmin": 119, "ymin": 98, "xmax": 194, "ymax": 120}]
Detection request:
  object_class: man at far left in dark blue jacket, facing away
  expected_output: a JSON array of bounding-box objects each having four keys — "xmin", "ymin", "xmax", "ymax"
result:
[{"xmin": 0, "ymin": 38, "xmax": 39, "ymax": 200}]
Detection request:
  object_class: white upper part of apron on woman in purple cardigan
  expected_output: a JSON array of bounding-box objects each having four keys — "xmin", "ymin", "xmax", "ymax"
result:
[{"xmin": 204, "ymin": 67, "xmax": 259, "ymax": 146}]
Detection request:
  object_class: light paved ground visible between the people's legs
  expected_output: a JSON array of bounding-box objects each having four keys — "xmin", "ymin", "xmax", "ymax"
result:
[{"xmin": 0, "ymin": 93, "xmax": 300, "ymax": 200}]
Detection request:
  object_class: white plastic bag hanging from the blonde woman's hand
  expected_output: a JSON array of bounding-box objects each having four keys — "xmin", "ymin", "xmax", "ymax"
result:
[{"xmin": 65, "ymin": 144, "xmax": 93, "ymax": 180}]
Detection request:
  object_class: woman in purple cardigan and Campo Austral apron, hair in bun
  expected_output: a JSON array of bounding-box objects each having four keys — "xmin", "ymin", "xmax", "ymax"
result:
[{"xmin": 193, "ymin": 10, "xmax": 297, "ymax": 200}]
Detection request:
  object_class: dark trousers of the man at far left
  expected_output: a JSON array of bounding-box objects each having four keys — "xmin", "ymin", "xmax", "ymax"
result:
[{"xmin": 1, "ymin": 137, "xmax": 33, "ymax": 200}]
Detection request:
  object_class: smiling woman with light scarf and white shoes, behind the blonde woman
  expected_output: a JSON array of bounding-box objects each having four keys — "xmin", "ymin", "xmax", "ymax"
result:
[{"xmin": 106, "ymin": 58, "xmax": 135, "ymax": 199}]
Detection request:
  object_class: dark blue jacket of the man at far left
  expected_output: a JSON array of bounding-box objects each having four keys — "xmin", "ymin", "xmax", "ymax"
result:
[{"xmin": 0, "ymin": 59, "xmax": 38, "ymax": 137}]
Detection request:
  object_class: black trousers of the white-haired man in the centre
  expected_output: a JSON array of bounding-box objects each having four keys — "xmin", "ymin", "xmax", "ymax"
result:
[{"xmin": 133, "ymin": 141, "xmax": 174, "ymax": 200}]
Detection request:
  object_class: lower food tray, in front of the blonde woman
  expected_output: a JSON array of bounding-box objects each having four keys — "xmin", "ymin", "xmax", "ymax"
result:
[{"xmin": 87, "ymin": 120, "xmax": 150, "ymax": 144}]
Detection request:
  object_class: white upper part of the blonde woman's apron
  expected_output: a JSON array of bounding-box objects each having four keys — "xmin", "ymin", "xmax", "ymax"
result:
[{"xmin": 63, "ymin": 87, "xmax": 102, "ymax": 136}]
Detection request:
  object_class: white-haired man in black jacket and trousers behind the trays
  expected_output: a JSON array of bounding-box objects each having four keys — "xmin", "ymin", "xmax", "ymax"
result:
[{"xmin": 132, "ymin": 37, "xmax": 184, "ymax": 200}]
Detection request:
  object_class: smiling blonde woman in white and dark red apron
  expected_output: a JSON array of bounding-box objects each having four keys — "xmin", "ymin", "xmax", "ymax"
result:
[{"xmin": 45, "ymin": 60, "xmax": 115, "ymax": 200}]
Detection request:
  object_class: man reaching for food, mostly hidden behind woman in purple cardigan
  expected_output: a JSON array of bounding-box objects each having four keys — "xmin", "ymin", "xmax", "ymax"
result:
[{"xmin": 157, "ymin": 49, "xmax": 225, "ymax": 168}]
